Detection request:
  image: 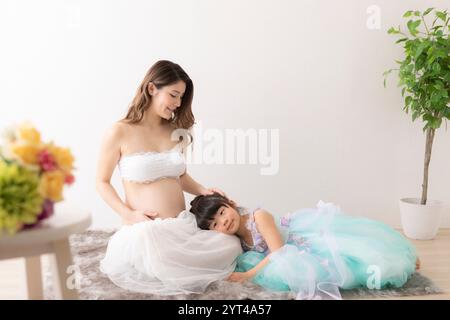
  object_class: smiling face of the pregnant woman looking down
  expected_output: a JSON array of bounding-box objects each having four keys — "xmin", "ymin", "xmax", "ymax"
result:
[{"xmin": 149, "ymin": 80, "xmax": 186, "ymax": 120}]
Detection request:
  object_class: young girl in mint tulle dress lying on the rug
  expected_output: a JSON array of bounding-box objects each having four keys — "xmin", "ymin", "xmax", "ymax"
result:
[{"xmin": 190, "ymin": 193, "xmax": 419, "ymax": 299}]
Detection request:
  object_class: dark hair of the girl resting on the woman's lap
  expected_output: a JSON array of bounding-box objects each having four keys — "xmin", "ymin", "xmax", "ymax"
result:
[{"xmin": 189, "ymin": 192, "xmax": 235, "ymax": 230}]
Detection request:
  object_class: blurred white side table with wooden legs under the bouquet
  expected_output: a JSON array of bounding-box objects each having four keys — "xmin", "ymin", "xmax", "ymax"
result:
[{"xmin": 0, "ymin": 202, "xmax": 92, "ymax": 299}]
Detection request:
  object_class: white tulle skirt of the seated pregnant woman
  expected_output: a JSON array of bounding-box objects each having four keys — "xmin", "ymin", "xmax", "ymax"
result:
[{"xmin": 100, "ymin": 210, "xmax": 242, "ymax": 295}]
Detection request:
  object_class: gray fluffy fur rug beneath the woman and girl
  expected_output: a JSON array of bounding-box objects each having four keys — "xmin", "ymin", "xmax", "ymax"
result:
[{"xmin": 43, "ymin": 230, "xmax": 442, "ymax": 300}]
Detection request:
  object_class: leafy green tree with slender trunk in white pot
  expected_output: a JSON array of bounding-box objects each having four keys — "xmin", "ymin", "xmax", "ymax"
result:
[{"xmin": 383, "ymin": 8, "xmax": 450, "ymax": 240}]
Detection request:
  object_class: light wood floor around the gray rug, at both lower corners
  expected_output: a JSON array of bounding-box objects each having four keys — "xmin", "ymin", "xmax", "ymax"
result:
[{"xmin": 0, "ymin": 229, "xmax": 450, "ymax": 300}]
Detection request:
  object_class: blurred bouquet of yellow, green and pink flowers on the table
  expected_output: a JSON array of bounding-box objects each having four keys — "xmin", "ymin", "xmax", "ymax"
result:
[{"xmin": 0, "ymin": 124, "xmax": 75, "ymax": 234}]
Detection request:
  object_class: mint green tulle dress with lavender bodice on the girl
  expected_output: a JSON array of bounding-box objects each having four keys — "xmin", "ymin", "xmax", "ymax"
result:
[{"xmin": 235, "ymin": 201, "xmax": 416, "ymax": 299}]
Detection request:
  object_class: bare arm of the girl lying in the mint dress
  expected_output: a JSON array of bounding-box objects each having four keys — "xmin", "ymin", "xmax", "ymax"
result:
[{"xmin": 228, "ymin": 209, "xmax": 284, "ymax": 282}]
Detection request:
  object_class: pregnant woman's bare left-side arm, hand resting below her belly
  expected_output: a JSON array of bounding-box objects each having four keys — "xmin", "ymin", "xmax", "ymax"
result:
[{"xmin": 96, "ymin": 123, "xmax": 153, "ymax": 223}]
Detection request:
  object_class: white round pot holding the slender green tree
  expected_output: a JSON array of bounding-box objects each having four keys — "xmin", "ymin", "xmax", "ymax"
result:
[{"xmin": 400, "ymin": 198, "xmax": 445, "ymax": 240}]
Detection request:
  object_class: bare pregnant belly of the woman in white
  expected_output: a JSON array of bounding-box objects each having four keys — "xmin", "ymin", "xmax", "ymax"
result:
[{"xmin": 123, "ymin": 178, "xmax": 186, "ymax": 219}]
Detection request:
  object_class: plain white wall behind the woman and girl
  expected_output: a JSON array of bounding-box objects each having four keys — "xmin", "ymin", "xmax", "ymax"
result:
[{"xmin": 0, "ymin": 0, "xmax": 450, "ymax": 228}]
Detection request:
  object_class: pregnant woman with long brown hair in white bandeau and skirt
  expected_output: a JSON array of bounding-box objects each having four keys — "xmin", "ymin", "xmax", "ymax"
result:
[{"xmin": 96, "ymin": 60, "xmax": 242, "ymax": 295}]
